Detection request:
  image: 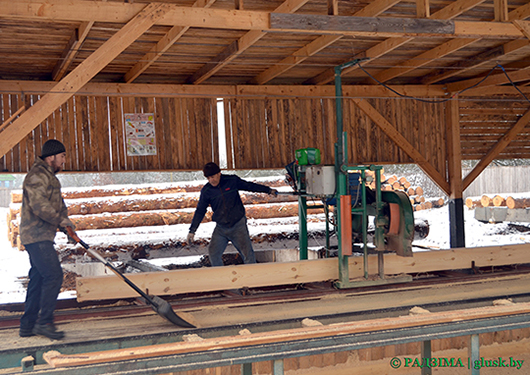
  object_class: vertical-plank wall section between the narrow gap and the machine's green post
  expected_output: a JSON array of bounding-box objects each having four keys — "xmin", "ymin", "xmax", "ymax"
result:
[{"xmin": 224, "ymin": 99, "xmax": 336, "ymax": 169}]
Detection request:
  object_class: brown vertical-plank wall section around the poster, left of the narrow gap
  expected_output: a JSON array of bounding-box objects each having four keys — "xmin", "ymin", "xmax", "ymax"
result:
[{"xmin": 0, "ymin": 94, "xmax": 219, "ymax": 173}]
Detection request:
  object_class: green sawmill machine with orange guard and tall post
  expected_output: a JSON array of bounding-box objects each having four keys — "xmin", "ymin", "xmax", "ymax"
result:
[{"xmin": 286, "ymin": 60, "xmax": 414, "ymax": 288}]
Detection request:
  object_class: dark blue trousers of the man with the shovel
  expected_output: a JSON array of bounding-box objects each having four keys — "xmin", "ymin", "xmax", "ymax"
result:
[{"xmin": 20, "ymin": 241, "xmax": 63, "ymax": 329}]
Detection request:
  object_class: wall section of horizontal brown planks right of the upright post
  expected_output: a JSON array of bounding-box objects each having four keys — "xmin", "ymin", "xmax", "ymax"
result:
[{"xmin": 459, "ymin": 98, "xmax": 530, "ymax": 160}]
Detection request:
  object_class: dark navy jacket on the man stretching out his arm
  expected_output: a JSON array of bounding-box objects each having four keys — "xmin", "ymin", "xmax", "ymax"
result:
[{"xmin": 190, "ymin": 174, "xmax": 271, "ymax": 233}]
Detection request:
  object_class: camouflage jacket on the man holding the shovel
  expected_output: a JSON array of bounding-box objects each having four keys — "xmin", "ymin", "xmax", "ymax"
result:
[{"xmin": 20, "ymin": 157, "xmax": 68, "ymax": 245}]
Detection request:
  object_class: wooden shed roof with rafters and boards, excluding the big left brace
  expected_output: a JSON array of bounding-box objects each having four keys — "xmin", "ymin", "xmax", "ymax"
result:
[{"xmin": 0, "ymin": 0, "xmax": 530, "ymax": 88}]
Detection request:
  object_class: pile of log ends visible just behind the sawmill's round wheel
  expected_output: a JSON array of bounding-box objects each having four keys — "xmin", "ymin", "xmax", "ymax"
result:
[{"xmin": 365, "ymin": 171, "xmax": 445, "ymax": 211}]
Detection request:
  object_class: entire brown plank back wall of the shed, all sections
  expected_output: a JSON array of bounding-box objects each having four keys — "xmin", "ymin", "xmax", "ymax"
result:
[{"xmin": 4, "ymin": 94, "xmax": 506, "ymax": 180}]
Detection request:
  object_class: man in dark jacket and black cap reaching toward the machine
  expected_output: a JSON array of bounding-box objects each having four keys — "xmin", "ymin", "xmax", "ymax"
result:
[{"xmin": 187, "ymin": 163, "xmax": 276, "ymax": 266}]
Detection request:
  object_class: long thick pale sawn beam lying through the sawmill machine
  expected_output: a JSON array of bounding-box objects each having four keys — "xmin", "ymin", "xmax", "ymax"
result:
[{"xmin": 77, "ymin": 244, "xmax": 530, "ymax": 302}]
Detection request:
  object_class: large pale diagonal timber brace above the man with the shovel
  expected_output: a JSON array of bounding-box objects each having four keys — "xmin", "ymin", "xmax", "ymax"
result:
[{"xmin": 0, "ymin": 4, "xmax": 167, "ymax": 159}]
